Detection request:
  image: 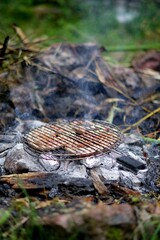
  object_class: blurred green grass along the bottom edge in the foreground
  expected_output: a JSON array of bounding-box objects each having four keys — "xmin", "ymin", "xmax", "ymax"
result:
[{"xmin": 0, "ymin": 194, "xmax": 160, "ymax": 240}]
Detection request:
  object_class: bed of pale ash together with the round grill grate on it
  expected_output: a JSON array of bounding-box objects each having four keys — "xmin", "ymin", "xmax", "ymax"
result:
[{"xmin": 0, "ymin": 116, "xmax": 159, "ymax": 193}]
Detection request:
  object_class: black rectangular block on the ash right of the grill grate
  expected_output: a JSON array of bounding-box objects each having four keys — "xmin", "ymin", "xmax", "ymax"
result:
[{"xmin": 117, "ymin": 156, "xmax": 146, "ymax": 172}]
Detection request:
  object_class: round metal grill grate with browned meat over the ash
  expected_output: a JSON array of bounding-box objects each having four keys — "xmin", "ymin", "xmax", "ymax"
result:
[{"xmin": 24, "ymin": 120, "xmax": 121, "ymax": 160}]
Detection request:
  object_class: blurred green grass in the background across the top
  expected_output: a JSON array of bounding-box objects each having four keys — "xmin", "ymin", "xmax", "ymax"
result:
[{"xmin": 0, "ymin": 0, "xmax": 160, "ymax": 50}]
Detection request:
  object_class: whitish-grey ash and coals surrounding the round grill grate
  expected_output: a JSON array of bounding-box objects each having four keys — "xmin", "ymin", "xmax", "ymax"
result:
[{"xmin": 0, "ymin": 120, "xmax": 160, "ymax": 191}]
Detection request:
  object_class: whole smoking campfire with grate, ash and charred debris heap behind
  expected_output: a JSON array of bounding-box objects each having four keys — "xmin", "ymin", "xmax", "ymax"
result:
[{"xmin": 0, "ymin": 43, "xmax": 160, "ymax": 202}]
